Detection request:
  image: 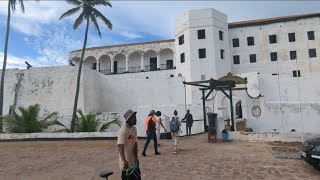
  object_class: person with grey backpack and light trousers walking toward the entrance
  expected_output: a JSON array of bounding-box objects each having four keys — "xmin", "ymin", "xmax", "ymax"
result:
[{"xmin": 170, "ymin": 110, "xmax": 181, "ymax": 154}]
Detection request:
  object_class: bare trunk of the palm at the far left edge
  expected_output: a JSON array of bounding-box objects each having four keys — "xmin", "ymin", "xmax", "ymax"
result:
[{"xmin": 0, "ymin": 1, "xmax": 11, "ymax": 133}]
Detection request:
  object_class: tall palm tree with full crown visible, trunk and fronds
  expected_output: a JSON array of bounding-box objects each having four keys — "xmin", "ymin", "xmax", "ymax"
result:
[{"xmin": 60, "ymin": 0, "xmax": 112, "ymax": 132}]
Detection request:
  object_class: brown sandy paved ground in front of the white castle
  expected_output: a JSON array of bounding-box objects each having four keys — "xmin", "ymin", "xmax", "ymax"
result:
[{"xmin": 0, "ymin": 134, "xmax": 320, "ymax": 180}]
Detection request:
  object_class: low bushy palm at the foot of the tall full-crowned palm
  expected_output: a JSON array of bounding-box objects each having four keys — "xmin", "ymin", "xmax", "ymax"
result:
[{"xmin": 52, "ymin": 109, "xmax": 121, "ymax": 132}]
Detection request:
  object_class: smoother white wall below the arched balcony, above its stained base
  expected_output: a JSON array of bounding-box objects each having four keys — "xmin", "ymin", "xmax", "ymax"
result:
[{"xmin": 84, "ymin": 68, "xmax": 185, "ymax": 112}]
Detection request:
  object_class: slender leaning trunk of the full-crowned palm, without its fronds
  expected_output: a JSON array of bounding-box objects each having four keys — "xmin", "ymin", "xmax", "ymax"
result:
[{"xmin": 70, "ymin": 17, "xmax": 89, "ymax": 132}]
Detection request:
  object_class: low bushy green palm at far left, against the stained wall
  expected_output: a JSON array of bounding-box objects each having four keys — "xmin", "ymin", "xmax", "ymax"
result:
[{"xmin": 4, "ymin": 104, "xmax": 58, "ymax": 133}]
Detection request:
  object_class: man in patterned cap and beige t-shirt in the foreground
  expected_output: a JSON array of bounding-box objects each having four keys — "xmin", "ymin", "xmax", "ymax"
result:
[{"xmin": 117, "ymin": 110, "xmax": 141, "ymax": 180}]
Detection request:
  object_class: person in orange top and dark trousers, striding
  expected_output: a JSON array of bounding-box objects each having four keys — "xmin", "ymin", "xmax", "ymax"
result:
[{"xmin": 142, "ymin": 110, "xmax": 160, "ymax": 156}]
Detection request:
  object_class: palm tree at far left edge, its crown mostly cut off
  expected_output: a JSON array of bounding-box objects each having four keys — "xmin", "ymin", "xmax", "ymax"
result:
[{"xmin": 0, "ymin": 0, "xmax": 39, "ymax": 133}]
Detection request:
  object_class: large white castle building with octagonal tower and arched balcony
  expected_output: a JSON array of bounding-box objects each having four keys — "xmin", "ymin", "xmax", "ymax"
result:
[{"xmin": 4, "ymin": 9, "xmax": 320, "ymax": 141}]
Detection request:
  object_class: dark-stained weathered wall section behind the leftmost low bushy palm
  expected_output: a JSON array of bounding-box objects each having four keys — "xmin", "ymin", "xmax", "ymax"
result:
[{"xmin": 4, "ymin": 66, "xmax": 83, "ymax": 115}]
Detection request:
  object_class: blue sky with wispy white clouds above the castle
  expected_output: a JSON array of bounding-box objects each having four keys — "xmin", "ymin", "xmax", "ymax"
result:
[{"xmin": 0, "ymin": 0, "xmax": 320, "ymax": 68}]
